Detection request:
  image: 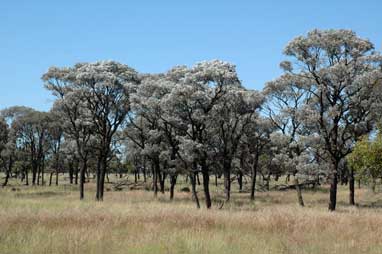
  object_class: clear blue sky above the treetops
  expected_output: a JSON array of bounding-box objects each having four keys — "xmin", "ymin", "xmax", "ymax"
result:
[{"xmin": 0, "ymin": 0, "xmax": 382, "ymax": 110}]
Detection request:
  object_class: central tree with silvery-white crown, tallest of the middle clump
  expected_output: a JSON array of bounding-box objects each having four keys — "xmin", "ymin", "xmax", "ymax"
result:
[{"xmin": 163, "ymin": 60, "xmax": 240, "ymax": 208}]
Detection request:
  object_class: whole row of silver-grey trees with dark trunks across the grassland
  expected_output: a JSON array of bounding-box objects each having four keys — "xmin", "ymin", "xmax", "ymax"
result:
[{"xmin": 0, "ymin": 30, "xmax": 382, "ymax": 211}]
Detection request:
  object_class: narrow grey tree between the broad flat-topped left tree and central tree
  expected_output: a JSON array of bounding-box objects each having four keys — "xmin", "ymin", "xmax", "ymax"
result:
[{"xmin": 125, "ymin": 74, "xmax": 173, "ymax": 197}]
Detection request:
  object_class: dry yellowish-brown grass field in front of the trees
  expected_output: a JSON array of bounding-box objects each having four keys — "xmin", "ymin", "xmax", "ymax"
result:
[{"xmin": 0, "ymin": 177, "xmax": 382, "ymax": 254}]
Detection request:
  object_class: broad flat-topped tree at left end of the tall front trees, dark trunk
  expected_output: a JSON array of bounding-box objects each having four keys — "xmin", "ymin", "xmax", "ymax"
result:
[{"xmin": 43, "ymin": 61, "xmax": 139, "ymax": 201}]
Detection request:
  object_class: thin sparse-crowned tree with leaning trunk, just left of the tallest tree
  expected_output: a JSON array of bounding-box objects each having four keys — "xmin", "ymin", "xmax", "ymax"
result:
[{"xmin": 264, "ymin": 71, "xmax": 310, "ymax": 206}]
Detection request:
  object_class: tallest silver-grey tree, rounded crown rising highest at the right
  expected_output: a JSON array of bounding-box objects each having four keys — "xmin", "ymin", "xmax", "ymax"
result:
[{"xmin": 276, "ymin": 30, "xmax": 382, "ymax": 211}]
